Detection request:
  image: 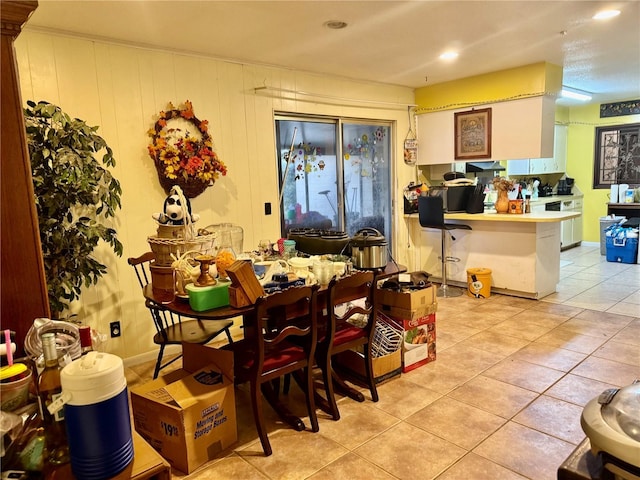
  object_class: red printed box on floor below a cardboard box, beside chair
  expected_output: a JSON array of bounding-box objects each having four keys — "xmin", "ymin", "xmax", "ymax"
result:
[{"xmin": 394, "ymin": 313, "xmax": 436, "ymax": 373}]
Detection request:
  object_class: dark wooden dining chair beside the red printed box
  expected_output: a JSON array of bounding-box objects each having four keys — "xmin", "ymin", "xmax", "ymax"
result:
[{"xmin": 316, "ymin": 271, "xmax": 378, "ymax": 420}]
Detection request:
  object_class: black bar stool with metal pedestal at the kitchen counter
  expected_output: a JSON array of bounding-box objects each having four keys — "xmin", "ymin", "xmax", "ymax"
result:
[{"xmin": 418, "ymin": 196, "xmax": 471, "ymax": 297}]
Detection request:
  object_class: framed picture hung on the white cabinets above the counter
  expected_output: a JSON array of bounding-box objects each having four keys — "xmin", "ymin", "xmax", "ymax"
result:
[{"xmin": 454, "ymin": 108, "xmax": 491, "ymax": 160}]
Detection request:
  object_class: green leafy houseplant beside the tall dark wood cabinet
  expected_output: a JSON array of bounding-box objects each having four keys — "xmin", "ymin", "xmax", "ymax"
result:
[{"xmin": 24, "ymin": 101, "xmax": 122, "ymax": 318}]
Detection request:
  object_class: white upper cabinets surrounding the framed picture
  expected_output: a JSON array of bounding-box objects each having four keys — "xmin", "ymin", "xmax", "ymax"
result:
[{"xmin": 417, "ymin": 96, "xmax": 555, "ymax": 165}]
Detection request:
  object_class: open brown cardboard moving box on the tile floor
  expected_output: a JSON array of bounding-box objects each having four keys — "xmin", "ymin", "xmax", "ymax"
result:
[{"xmin": 131, "ymin": 343, "xmax": 238, "ymax": 473}]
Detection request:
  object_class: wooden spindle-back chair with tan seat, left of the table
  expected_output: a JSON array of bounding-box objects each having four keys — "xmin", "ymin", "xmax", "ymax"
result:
[{"xmin": 127, "ymin": 252, "xmax": 233, "ymax": 379}]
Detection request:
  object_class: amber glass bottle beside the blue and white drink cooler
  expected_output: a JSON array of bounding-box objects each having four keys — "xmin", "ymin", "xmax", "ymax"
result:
[{"xmin": 38, "ymin": 332, "xmax": 70, "ymax": 466}]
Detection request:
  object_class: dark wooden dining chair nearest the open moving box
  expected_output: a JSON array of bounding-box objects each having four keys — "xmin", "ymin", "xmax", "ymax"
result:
[{"xmin": 223, "ymin": 285, "xmax": 319, "ymax": 456}]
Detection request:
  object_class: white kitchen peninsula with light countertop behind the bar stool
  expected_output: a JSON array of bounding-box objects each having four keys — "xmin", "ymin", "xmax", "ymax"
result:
[{"xmin": 405, "ymin": 211, "xmax": 581, "ymax": 299}]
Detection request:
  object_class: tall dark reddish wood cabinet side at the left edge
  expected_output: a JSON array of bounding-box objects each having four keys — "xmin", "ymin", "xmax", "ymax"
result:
[{"xmin": 0, "ymin": 0, "xmax": 50, "ymax": 355}]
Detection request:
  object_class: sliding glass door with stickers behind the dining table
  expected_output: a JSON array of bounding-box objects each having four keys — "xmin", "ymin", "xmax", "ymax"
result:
[{"xmin": 275, "ymin": 115, "xmax": 392, "ymax": 238}]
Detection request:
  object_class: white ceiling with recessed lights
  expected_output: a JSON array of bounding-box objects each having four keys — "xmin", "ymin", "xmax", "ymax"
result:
[{"xmin": 26, "ymin": 0, "xmax": 640, "ymax": 102}]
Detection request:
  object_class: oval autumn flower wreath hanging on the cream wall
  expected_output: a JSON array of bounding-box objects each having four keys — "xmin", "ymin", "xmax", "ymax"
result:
[{"xmin": 148, "ymin": 100, "xmax": 227, "ymax": 198}]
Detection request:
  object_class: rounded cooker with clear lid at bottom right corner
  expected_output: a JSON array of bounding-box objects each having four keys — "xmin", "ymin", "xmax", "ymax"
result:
[{"xmin": 580, "ymin": 380, "xmax": 640, "ymax": 480}]
